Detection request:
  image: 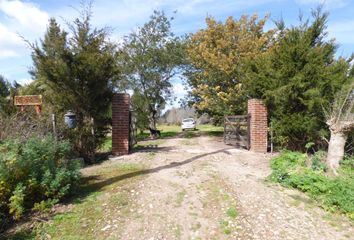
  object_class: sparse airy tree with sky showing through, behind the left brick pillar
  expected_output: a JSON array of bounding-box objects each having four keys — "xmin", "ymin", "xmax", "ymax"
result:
[{"xmin": 120, "ymin": 11, "xmax": 184, "ymax": 129}]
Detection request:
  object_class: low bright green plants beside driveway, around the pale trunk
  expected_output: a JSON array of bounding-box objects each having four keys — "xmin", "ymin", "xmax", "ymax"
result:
[{"xmin": 269, "ymin": 151, "xmax": 354, "ymax": 220}]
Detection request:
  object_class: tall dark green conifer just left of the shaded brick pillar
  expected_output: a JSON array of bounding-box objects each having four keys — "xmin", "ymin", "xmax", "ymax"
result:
[{"xmin": 30, "ymin": 6, "xmax": 118, "ymax": 161}]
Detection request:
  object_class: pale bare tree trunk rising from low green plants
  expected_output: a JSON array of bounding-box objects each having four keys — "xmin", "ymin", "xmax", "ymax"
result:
[{"xmin": 327, "ymin": 130, "xmax": 347, "ymax": 175}]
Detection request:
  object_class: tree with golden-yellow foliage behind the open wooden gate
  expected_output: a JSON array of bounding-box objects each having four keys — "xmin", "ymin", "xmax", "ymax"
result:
[{"xmin": 186, "ymin": 15, "xmax": 273, "ymax": 118}]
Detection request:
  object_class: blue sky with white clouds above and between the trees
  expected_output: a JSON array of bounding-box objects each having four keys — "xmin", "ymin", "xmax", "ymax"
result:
[{"xmin": 0, "ymin": 0, "xmax": 354, "ymax": 105}]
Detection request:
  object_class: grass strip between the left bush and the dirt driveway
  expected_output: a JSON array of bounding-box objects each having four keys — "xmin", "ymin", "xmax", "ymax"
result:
[{"xmin": 7, "ymin": 164, "xmax": 143, "ymax": 240}]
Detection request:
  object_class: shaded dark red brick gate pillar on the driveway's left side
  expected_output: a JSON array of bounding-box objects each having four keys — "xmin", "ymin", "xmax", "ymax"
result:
[{"xmin": 112, "ymin": 93, "xmax": 130, "ymax": 155}]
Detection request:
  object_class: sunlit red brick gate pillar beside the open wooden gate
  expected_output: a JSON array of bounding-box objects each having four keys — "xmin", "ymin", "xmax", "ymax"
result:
[{"xmin": 248, "ymin": 99, "xmax": 268, "ymax": 153}]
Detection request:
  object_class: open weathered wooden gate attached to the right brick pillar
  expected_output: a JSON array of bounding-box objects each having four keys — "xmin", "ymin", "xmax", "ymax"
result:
[{"xmin": 224, "ymin": 115, "xmax": 251, "ymax": 149}]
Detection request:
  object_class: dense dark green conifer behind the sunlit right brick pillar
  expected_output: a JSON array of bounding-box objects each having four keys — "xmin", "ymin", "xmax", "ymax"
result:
[{"xmin": 245, "ymin": 9, "xmax": 348, "ymax": 150}]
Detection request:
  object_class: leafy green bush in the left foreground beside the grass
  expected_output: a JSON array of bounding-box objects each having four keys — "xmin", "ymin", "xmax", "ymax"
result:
[{"xmin": 0, "ymin": 136, "xmax": 80, "ymax": 222}]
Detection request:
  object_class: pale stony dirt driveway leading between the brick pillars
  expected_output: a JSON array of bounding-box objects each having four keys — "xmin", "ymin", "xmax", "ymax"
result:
[{"xmin": 88, "ymin": 136, "xmax": 353, "ymax": 240}]
